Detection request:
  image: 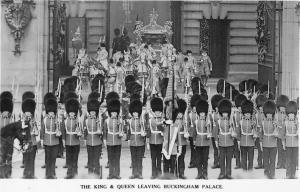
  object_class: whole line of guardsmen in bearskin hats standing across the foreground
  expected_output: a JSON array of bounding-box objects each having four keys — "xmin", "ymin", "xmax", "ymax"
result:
[{"xmin": 0, "ymin": 80, "xmax": 298, "ymax": 179}]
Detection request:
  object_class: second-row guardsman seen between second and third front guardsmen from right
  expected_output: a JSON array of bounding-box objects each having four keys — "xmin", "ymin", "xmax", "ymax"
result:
[{"xmin": 254, "ymin": 94, "xmax": 267, "ymax": 169}]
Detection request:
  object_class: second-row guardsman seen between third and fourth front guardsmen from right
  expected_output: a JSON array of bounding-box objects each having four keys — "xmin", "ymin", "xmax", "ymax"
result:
[{"xmin": 232, "ymin": 94, "xmax": 247, "ymax": 169}]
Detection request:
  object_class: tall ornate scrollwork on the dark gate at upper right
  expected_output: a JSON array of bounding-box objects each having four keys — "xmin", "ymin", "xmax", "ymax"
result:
[{"xmin": 255, "ymin": 1, "xmax": 270, "ymax": 63}]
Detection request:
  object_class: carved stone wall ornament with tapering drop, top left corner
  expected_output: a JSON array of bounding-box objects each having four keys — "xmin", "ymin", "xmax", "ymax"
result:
[{"xmin": 2, "ymin": 0, "xmax": 35, "ymax": 55}]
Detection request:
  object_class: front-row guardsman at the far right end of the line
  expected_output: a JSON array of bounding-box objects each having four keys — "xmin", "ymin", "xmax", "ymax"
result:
[{"xmin": 282, "ymin": 101, "xmax": 299, "ymax": 179}]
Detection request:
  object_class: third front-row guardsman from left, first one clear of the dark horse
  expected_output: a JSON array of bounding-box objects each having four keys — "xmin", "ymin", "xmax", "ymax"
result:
[{"xmin": 41, "ymin": 98, "xmax": 62, "ymax": 179}]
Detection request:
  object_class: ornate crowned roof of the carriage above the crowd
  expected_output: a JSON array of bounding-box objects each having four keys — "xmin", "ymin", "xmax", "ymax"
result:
[{"xmin": 133, "ymin": 8, "xmax": 173, "ymax": 42}]
